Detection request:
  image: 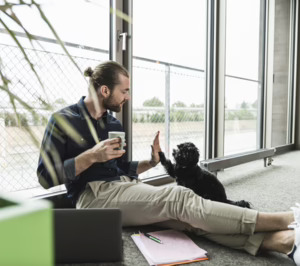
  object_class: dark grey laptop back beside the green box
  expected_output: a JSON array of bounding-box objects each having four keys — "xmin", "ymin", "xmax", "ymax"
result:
[{"xmin": 54, "ymin": 209, "xmax": 123, "ymax": 263}]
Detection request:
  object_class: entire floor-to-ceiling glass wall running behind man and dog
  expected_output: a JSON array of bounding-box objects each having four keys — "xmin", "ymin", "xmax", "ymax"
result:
[{"xmin": 0, "ymin": 0, "xmax": 297, "ymax": 195}]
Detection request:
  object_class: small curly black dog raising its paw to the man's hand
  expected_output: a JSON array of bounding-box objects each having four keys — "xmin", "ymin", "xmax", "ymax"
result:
[{"xmin": 159, "ymin": 142, "xmax": 251, "ymax": 208}]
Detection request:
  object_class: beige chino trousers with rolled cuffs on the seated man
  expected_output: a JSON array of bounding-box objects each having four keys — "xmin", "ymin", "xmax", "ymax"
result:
[{"xmin": 76, "ymin": 176, "xmax": 264, "ymax": 255}]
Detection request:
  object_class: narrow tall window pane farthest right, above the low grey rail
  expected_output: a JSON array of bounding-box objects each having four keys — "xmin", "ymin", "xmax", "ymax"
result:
[{"xmin": 224, "ymin": 0, "xmax": 260, "ymax": 155}]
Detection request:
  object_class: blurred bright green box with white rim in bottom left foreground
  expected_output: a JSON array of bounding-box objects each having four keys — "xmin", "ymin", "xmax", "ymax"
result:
[{"xmin": 0, "ymin": 193, "xmax": 54, "ymax": 266}]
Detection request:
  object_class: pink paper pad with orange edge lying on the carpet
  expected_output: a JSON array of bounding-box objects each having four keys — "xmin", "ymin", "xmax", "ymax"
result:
[{"xmin": 131, "ymin": 230, "xmax": 208, "ymax": 265}]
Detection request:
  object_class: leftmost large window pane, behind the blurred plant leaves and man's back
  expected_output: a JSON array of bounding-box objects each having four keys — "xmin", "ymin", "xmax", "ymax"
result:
[{"xmin": 0, "ymin": 0, "xmax": 109, "ymax": 195}]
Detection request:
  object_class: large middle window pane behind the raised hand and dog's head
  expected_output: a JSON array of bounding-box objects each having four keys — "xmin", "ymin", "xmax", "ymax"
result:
[{"xmin": 132, "ymin": 0, "xmax": 206, "ymax": 178}]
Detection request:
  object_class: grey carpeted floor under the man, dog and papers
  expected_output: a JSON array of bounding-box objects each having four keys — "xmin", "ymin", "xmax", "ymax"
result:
[{"xmin": 59, "ymin": 151, "xmax": 300, "ymax": 266}]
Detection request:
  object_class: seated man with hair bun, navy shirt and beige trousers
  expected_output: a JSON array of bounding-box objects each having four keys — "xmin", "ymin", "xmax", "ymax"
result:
[{"xmin": 37, "ymin": 61, "xmax": 300, "ymax": 265}]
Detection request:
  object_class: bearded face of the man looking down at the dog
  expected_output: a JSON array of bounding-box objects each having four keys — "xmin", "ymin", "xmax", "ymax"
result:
[{"xmin": 103, "ymin": 74, "xmax": 130, "ymax": 113}]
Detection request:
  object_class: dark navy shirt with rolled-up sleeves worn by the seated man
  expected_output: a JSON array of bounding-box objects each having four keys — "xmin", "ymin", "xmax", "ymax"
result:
[{"xmin": 37, "ymin": 97, "xmax": 138, "ymax": 202}]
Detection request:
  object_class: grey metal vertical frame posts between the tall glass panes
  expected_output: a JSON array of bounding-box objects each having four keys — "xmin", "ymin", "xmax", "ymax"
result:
[{"xmin": 1, "ymin": 0, "xmax": 300, "ymax": 194}]
